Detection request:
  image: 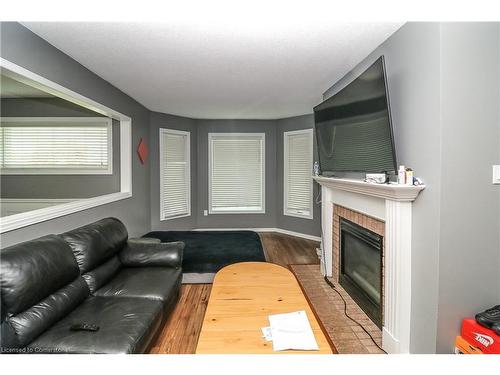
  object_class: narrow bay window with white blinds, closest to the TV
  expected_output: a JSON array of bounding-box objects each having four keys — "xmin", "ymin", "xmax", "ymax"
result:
[{"xmin": 283, "ymin": 129, "xmax": 313, "ymax": 219}]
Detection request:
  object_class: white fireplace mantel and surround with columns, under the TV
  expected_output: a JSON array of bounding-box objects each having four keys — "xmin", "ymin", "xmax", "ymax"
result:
[{"xmin": 314, "ymin": 176, "xmax": 425, "ymax": 353}]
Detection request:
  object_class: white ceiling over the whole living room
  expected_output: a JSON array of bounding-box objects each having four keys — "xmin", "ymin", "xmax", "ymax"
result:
[{"xmin": 23, "ymin": 20, "xmax": 402, "ymax": 119}]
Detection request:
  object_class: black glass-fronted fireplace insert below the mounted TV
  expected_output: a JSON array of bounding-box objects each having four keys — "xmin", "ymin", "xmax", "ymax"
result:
[{"xmin": 339, "ymin": 217, "xmax": 383, "ymax": 329}]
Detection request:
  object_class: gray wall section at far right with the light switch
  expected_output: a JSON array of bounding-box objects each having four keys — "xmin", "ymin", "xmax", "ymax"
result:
[{"xmin": 437, "ymin": 23, "xmax": 500, "ymax": 352}]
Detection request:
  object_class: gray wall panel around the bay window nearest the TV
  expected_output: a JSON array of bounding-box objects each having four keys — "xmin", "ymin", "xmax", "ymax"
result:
[{"xmin": 276, "ymin": 114, "xmax": 321, "ymax": 237}]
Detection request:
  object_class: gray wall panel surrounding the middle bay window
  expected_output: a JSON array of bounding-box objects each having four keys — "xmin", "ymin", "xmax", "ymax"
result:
[{"xmin": 193, "ymin": 120, "xmax": 279, "ymax": 228}]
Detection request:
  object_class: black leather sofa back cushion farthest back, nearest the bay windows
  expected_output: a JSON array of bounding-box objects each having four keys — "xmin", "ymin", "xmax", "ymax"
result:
[{"xmin": 60, "ymin": 218, "xmax": 128, "ymax": 274}]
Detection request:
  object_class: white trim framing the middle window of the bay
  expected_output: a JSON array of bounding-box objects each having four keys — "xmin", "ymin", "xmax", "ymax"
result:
[{"xmin": 208, "ymin": 133, "xmax": 266, "ymax": 215}]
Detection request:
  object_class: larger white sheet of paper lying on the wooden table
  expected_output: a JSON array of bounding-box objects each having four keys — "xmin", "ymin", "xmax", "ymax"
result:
[{"xmin": 269, "ymin": 310, "xmax": 319, "ymax": 351}]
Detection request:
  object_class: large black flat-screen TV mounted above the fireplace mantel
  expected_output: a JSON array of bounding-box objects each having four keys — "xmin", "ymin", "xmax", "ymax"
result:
[{"xmin": 314, "ymin": 56, "xmax": 396, "ymax": 176}]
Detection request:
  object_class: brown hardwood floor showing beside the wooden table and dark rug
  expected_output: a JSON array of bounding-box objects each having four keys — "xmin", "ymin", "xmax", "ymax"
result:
[{"xmin": 150, "ymin": 232, "xmax": 319, "ymax": 354}]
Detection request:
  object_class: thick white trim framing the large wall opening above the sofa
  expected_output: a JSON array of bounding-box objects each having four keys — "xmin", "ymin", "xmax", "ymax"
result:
[{"xmin": 0, "ymin": 57, "xmax": 132, "ymax": 233}]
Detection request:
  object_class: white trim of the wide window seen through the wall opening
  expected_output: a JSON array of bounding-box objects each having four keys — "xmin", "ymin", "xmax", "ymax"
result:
[{"xmin": 0, "ymin": 117, "xmax": 113, "ymax": 176}]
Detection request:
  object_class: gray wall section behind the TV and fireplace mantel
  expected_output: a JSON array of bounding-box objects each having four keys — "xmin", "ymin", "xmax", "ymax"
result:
[{"xmin": 325, "ymin": 23, "xmax": 441, "ymax": 353}]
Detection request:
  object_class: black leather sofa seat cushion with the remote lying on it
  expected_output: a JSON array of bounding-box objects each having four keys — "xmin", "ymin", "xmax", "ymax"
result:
[{"xmin": 28, "ymin": 297, "xmax": 162, "ymax": 354}]
